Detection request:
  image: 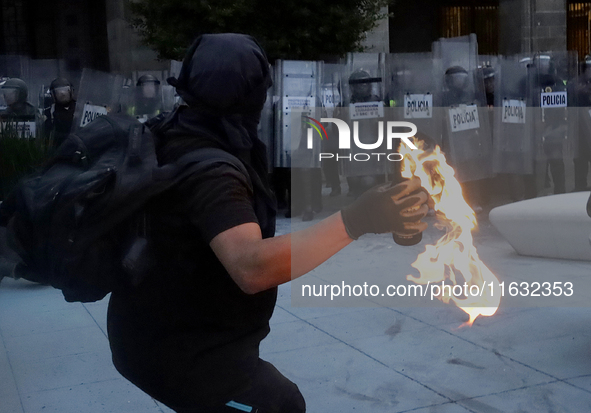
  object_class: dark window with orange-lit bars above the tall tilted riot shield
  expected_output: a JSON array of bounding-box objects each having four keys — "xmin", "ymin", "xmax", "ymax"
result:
[{"xmin": 439, "ymin": 0, "xmax": 499, "ymax": 55}]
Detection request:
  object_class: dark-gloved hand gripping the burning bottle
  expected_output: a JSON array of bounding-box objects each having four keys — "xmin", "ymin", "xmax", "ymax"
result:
[{"xmin": 341, "ymin": 177, "xmax": 429, "ymax": 239}]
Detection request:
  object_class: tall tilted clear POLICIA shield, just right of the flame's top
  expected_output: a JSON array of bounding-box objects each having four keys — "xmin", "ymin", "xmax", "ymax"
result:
[{"xmin": 433, "ymin": 34, "xmax": 492, "ymax": 182}]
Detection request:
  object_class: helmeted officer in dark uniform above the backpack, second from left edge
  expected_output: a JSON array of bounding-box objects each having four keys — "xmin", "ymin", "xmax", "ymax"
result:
[{"xmin": 44, "ymin": 78, "xmax": 76, "ymax": 147}]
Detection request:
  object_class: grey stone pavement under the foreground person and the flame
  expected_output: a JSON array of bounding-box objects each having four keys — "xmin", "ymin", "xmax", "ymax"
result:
[{"xmin": 0, "ymin": 211, "xmax": 591, "ymax": 413}]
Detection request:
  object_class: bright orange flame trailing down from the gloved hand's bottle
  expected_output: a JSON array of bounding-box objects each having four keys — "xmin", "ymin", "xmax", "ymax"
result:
[{"xmin": 400, "ymin": 139, "xmax": 501, "ymax": 326}]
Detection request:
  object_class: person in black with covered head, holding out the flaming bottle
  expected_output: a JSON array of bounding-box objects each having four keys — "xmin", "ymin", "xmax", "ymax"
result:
[{"xmin": 108, "ymin": 34, "xmax": 427, "ymax": 413}]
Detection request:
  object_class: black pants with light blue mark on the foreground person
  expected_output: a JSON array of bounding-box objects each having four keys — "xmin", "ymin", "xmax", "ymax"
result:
[{"xmin": 169, "ymin": 359, "xmax": 306, "ymax": 413}]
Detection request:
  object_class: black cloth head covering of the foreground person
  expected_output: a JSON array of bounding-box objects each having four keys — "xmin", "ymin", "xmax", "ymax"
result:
[{"xmin": 152, "ymin": 33, "xmax": 274, "ymax": 225}]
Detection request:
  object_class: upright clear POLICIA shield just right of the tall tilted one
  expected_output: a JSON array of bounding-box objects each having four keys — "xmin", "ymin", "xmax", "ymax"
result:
[{"xmin": 493, "ymin": 56, "xmax": 534, "ymax": 175}]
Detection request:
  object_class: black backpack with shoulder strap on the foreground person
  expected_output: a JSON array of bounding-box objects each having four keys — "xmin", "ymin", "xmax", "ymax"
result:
[{"xmin": 0, "ymin": 114, "xmax": 251, "ymax": 302}]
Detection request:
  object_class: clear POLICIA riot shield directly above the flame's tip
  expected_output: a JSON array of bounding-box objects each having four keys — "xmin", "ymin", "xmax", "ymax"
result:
[{"xmin": 386, "ymin": 53, "xmax": 442, "ymax": 145}]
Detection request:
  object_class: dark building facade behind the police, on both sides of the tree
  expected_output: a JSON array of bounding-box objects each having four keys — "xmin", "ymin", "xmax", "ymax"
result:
[{"xmin": 0, "ymin": 0, "xmax": 591, "ymax": 76}]
